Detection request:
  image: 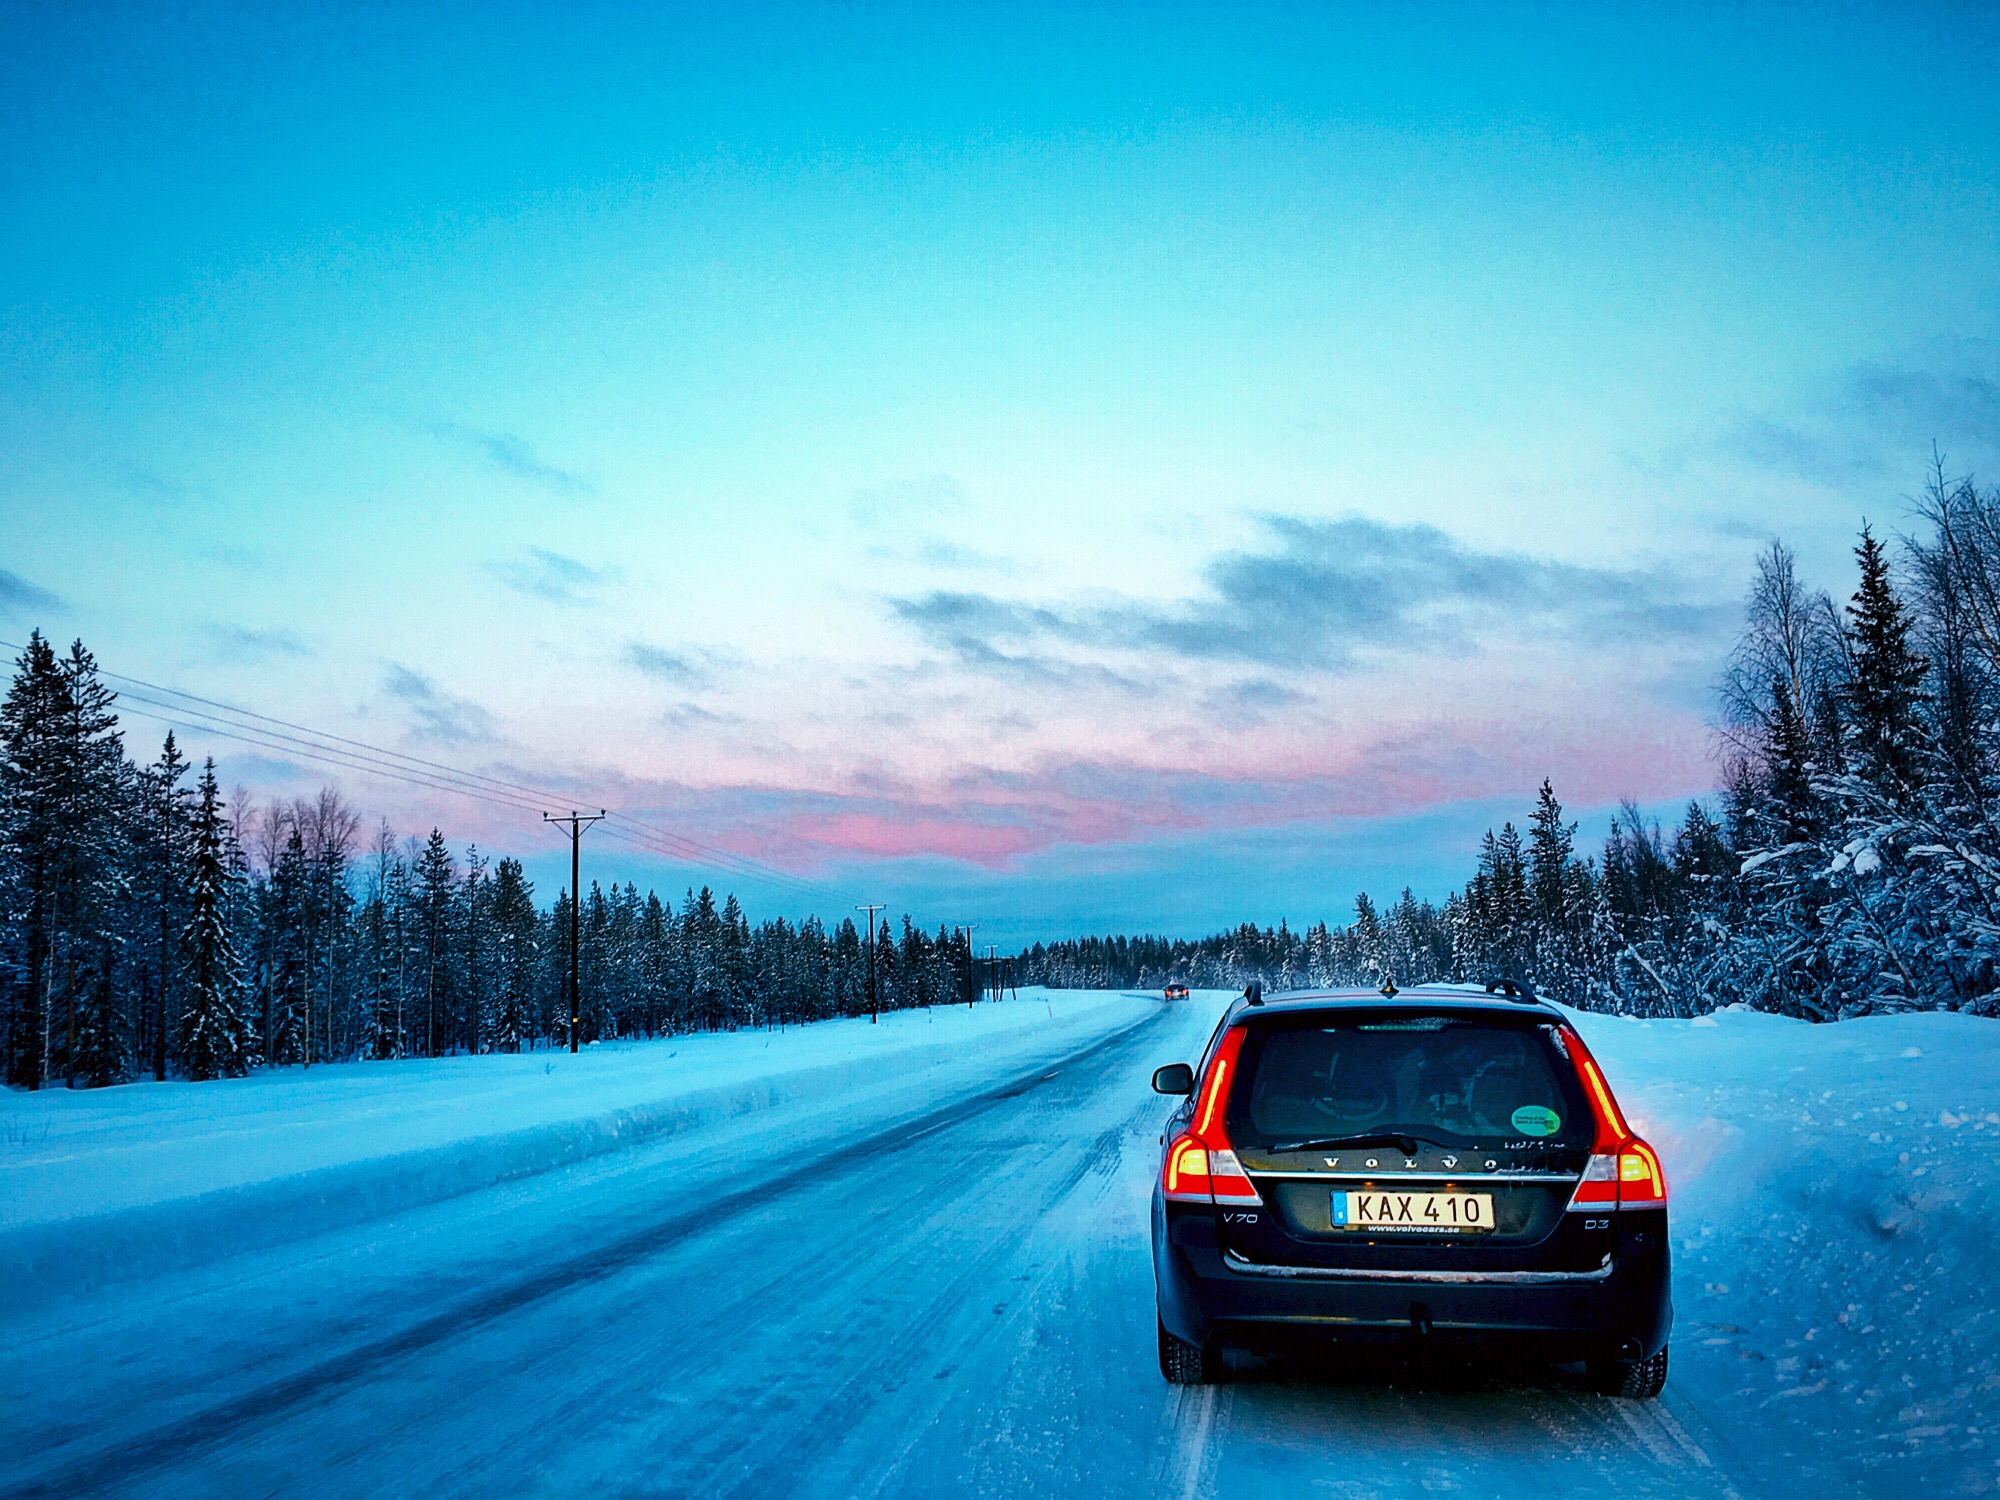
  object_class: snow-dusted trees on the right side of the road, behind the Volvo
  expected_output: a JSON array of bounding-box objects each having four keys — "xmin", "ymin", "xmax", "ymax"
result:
[{"xmin": 1018, "ymin": 466, "xmax": 2000, "ymax": 1020}]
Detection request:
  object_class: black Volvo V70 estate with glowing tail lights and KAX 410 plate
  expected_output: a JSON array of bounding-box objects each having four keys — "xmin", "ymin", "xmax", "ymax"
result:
[{"xmin": 1152, "ymin": 984, "xmax": 1674, "ymax": 1398}]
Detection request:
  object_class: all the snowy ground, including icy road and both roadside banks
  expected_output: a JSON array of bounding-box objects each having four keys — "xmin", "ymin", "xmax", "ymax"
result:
[{"xmin": 0, "ymin": 994, "xmax": 2000, "ymax": 1498}]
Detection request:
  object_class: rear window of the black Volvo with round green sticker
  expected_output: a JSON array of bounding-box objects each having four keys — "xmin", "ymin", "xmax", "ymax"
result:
[{"xmin": 1228, "ymin": 1016, "xmax": 1590, "ymax": 1148}]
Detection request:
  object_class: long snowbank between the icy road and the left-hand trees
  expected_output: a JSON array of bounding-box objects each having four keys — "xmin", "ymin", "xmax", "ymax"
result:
[{"xmin": 0, "ymin": 990, "xmax": 1158, "ymax": 1306}]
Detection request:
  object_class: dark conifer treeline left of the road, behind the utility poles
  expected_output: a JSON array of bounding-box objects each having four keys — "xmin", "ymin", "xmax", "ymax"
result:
[{"xmin": 0, "ymin": 630, "xmax": 974, "ymax": 1088}]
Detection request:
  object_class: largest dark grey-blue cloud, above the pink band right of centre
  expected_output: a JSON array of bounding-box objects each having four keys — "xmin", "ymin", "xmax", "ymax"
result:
[{"xmin": 890, "ymin": 516, "xmax": 1732, "ymax": 680}]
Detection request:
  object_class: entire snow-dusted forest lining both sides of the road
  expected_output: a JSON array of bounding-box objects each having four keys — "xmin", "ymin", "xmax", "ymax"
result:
[{"xmin": 0, "ymin": 464, "xmax": 2000, "ymax": 1088}]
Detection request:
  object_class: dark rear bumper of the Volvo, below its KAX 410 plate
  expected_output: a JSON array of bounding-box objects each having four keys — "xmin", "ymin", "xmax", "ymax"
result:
[{"xmin": 1152, "ymin": 1194, "xmax": 1674, "ymax": 1360}]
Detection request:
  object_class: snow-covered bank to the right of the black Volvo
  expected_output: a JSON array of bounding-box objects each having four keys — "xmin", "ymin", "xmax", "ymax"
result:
[{"xmin": 1578, "ymin": 1010, "xmax": 2000, "ymax": 1494}]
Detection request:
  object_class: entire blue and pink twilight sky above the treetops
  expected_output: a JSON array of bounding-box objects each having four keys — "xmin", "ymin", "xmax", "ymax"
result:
[{"xmin": 0, "ymin": 6, "xmax": 2000, "ymax": 938}]
